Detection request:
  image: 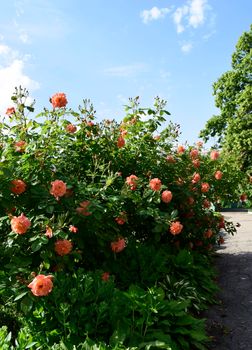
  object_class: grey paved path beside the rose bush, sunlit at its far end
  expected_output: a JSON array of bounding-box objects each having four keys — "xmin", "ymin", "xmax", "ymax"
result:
[{"xmin": 206, "ymin": 212, "xmax": 252, "ymax": 350}]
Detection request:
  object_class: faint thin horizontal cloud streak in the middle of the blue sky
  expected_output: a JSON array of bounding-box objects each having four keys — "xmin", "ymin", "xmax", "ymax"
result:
[{"xmin": 104, "ymin": 63, "xmax": 148, "ymax": 78}]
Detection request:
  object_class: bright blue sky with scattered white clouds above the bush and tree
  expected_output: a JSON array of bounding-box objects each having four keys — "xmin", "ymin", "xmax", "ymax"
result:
[{"xmin": 0, "ymin": 0, "xmax": 252, "ymax": 143}]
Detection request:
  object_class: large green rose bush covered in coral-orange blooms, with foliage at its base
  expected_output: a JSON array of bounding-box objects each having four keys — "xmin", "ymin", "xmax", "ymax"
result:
[{"xmin": 0, "ymin": 89, "xmax": 242, "ymax": 350}]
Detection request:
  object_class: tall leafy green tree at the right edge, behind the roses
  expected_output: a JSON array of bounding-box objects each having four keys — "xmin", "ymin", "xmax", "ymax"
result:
[{"xmin": 200, "ymin": 25, "xmax": 252, "ymax": 175}]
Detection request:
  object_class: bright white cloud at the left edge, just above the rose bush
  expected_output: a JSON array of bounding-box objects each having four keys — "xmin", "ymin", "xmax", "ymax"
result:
[{"xmin": 0, "ymin": 45, "xmax": 39, "ymax": 114}]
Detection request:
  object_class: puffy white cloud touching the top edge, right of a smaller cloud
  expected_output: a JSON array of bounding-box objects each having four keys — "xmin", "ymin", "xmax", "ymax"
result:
[{"xmin": 173, "ymin": 0, "xmax": 208, "ymax": 33}]
